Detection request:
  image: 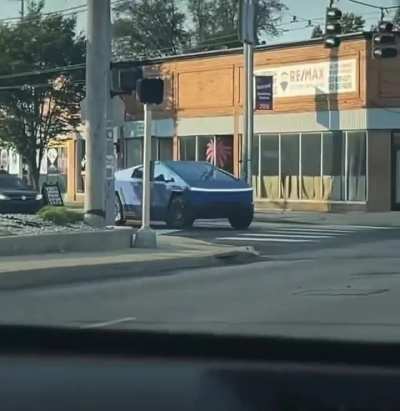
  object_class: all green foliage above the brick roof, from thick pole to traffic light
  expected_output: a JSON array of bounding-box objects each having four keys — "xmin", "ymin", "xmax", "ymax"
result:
[{"xmin": 113, "ymin": 0, "xmax": 286, "ymax": 58}]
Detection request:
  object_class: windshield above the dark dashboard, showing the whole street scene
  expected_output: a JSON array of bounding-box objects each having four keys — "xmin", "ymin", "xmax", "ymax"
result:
[{"xmin": 0, "ymin": 0, "xmax": 400, "ymax": 348}]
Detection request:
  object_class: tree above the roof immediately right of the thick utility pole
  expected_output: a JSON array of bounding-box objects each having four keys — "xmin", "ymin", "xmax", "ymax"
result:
[{"xmin": 113, "ymin": 0, "xmax": 189, "ymax": 58}]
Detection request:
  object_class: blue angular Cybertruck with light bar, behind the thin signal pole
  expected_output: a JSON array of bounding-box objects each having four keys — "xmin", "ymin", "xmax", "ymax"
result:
[{"xmin": 115, "ymin": 161, "xmax": 253, "ymax": 229}]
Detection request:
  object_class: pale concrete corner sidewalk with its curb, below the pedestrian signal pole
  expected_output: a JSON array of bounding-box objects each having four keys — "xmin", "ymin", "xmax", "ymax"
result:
[{"xmin": 0, "ymin": 236, "xmax": 257, "ymax": 290}]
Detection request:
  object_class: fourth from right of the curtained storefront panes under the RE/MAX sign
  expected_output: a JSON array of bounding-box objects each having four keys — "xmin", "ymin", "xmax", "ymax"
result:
[{"xmin": 281, "ymin": 134, "xmax": 300, "ymax": 200}]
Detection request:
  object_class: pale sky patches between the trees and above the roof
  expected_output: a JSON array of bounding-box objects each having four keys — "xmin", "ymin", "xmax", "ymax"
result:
[{"xmin": 0, "ymin": 0, "xmax": 400, "ymax": 44}]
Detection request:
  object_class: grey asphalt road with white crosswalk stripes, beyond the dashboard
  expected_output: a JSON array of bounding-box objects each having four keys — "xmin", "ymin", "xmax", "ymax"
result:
[{"xmin": 0, "ymin": 222, "xmax": 400, "ymax": 340}]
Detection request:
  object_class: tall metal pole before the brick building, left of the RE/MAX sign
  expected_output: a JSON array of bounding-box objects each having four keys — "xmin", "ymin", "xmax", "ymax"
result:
[{"xmin": 240, "ymin": 0, "xmax": 256, "ymax": 186}]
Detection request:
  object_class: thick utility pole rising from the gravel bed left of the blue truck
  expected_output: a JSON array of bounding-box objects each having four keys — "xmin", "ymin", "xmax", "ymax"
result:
[{"xmin": 85, "ymin": 0, "xmax": 111, "ymax": 227}]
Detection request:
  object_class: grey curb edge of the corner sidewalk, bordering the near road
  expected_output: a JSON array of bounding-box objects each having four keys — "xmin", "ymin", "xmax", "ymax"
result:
[{"xmin": 0, "ymin": 247, "xmax": 258, "ymax": 290}]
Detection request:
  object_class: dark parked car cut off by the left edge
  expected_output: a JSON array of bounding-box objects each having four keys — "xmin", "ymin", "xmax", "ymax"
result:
[{"xmin": 0, "ymin": 174, "xmax": 43, "ymax": 213}]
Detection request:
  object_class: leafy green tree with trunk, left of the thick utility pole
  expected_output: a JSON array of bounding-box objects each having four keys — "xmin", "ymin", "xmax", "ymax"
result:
[{"xmin": 0, "ymin": 0, "xmax": 85, "ymax": 189}]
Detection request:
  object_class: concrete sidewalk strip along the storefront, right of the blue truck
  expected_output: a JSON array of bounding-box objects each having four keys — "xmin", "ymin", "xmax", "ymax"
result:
[{"xmin": 254, "ymin": 211, "xmax": 400, "ymax": 228}]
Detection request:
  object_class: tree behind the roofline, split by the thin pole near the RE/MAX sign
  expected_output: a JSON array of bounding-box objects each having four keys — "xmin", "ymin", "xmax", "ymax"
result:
[{"xmin": 188, "ymin": 0, "xmax": 286, "ymax": 48}]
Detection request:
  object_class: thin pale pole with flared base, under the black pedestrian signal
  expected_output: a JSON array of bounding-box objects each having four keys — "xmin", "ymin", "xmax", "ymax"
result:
[{"xmin": 135, "ymin": 104, "xmax": 157, "ymax": 248}]
